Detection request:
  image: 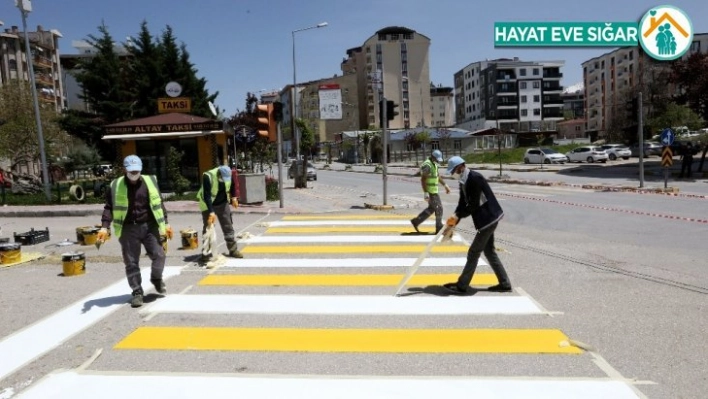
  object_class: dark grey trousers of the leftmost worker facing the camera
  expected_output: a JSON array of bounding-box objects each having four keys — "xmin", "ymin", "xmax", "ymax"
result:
[{"xmin": 118, "ymin": 223, "xmax": 165, "ymax": 293}]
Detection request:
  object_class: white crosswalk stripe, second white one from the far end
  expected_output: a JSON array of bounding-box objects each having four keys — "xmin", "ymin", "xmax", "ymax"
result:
[{"xmin": 240, "ymin": 235, "xmax": 463, "ymax": 245}]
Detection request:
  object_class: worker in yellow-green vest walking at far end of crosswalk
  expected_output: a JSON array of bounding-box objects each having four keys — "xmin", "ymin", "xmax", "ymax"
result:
[{"xmin": 411, "ymin": 150, "xmax": 450, "ymax": 234}]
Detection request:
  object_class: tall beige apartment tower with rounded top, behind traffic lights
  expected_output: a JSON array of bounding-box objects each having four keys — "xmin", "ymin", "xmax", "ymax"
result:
[{"xmin": 341, "ymin": 26, "xmax": 431, "ymax": 129}]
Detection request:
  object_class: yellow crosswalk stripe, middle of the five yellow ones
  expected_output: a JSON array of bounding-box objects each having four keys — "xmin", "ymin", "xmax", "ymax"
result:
[{"xmin": 241, "ymin": 244, "xmax": 469, "ymax": 255}]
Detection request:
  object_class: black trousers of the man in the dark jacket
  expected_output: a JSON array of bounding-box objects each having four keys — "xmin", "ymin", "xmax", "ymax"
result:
[{"xmin": 457, "ymin": 223, "xmax": 511, "ymax": 291}]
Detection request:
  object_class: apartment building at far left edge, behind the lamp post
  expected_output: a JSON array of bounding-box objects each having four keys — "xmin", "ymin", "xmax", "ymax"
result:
[{"xmin": 0, "ymin": 26, "xmax": 64, "ymax": 112}]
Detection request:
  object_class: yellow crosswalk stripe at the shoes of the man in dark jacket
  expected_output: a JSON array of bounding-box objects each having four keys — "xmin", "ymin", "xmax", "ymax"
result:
[{"xmin": 199, "ymin": 274, "xmax": 498, "ymax": 287}]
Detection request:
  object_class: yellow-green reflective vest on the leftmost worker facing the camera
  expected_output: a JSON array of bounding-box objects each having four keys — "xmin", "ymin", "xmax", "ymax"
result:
[{"xmin": 111, "ymin": 175, "xmax": 167, "ymax": 237}]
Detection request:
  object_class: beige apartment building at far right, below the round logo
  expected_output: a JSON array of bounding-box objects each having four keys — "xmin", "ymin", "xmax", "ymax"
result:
[{"xmin": 582, "ymin": 33, "xmax": 708, "ymax": 137}]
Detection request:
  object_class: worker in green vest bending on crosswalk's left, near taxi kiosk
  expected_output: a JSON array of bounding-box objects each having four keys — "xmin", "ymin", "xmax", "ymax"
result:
[{"xmin": 197, "ymin": 165, "xmax": 243, "ymax": 263}]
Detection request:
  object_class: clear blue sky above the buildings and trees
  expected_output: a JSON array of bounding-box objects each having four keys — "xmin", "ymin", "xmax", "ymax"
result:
[{"xmin": 0, "ymin": 0, "xmax": 708, "ymax": 115}]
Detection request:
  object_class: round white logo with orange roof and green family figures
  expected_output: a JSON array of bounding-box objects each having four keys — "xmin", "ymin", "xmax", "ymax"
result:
[{"xmin": 639, "ymin": 5, "xmax": 693, "ymax": 61}]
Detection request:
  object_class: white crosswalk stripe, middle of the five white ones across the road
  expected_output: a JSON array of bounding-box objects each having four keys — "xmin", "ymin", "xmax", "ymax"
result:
[{"xmin": 222, "ymin": 257, "xmax": 489, "ymax": 270}]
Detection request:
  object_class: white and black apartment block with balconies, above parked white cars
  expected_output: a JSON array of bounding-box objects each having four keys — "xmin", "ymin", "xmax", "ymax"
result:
[{"xmin": 455, "ymin": 57, "xmax": 565, "ymax": 132}]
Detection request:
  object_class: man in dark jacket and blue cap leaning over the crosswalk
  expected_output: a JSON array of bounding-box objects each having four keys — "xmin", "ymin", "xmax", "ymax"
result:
[{"xmin": 443, "ymin": 156, "xmax": 511, "ymax": 293}]
